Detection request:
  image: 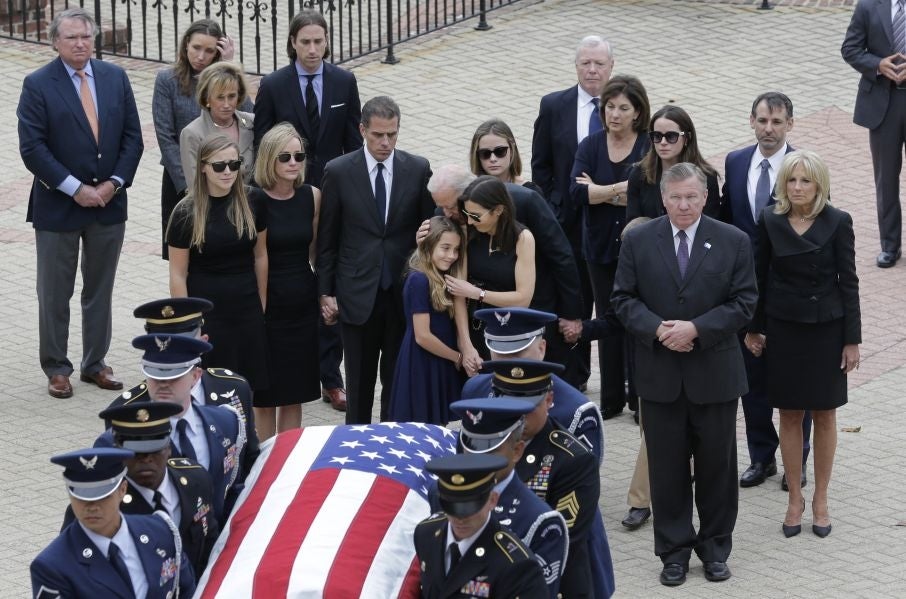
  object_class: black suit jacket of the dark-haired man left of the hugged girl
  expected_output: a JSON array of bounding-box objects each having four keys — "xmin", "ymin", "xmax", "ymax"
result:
[{"xmin": 317, "ymin": 148, "xmax": 435, "ymax": 325}]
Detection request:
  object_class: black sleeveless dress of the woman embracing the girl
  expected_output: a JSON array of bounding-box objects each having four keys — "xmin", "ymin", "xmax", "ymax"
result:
[{"xmin": 466, "ymin": 229, "xmax": 525, "ymax": 360}]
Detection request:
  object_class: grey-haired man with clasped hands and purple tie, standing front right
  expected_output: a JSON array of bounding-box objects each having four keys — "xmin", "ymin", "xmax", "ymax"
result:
[{"xmin": 611, "ymin": 163, "xmax": 758, "ymax": 586}]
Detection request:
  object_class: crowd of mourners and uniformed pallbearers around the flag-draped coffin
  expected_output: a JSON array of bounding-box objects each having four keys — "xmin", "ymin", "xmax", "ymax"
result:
[{"xmin": 17, "ymin": 3, "xmax": 884, "ymax": 598}]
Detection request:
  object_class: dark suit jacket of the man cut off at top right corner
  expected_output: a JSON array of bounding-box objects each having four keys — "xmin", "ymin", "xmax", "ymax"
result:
[{"xmin": 840, "ymin": 0, "xmax": 896, "ymax": 130}]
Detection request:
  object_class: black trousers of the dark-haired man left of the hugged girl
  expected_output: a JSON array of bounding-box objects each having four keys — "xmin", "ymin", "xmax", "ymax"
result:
[{"xmin": 341, "ymin": 289, "xmax": 406, "ymax": 424}]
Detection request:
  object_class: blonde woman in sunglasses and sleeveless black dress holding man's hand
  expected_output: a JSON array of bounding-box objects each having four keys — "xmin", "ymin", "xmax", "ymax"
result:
[{"xmin": 250, "ymin": 123, "xmax": 321, "ymax": 439}]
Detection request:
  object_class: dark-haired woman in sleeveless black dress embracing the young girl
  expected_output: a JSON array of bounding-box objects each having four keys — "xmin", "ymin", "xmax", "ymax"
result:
[{"xmin": 445, "ymin": 175, "xmax": 535, "ymax": 376}]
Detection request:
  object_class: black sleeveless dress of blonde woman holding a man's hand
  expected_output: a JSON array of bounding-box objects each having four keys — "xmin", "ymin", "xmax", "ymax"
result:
[{"xmin": 252, "ymin": 185, "xmax": 321, "ymax": 407}]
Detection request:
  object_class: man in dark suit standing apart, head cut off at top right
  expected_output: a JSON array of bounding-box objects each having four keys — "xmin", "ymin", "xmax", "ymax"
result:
[{"xmin": 840, "ymin": 0, "xmax": 906, "ymax": 268}]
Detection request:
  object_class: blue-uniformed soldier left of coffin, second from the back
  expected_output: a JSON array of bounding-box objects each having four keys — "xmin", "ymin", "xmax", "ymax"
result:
[{"xmin": 95, "ymin": 334, "xmax": 245, "ymax": 523}]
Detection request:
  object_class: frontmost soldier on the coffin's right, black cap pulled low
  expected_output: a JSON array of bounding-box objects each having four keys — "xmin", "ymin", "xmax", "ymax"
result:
[{"xmin": 414, "ymin": 454, "xmax": 548, "ymax": 599}]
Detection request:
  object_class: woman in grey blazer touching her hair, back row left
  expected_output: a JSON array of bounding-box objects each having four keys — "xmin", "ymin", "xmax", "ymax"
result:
[{"xmin": 151, "ymin": 19, "xmax": 252, "ymax": 260}]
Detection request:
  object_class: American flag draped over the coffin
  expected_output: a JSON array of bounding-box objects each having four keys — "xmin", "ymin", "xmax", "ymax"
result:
[{"xmin": 195, "ymin": 422, "xmax": 456, "ymax": 599}]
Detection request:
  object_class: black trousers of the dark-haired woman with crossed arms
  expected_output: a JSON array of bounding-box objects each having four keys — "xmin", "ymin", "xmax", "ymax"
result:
[{"xmin": 588, "ymin": 262, "xmax": 626, "ymax": 410}]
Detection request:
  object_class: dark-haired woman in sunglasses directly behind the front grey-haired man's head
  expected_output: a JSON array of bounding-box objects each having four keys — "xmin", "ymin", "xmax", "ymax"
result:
[{"xmin": 626, "ymin": 104, "xmax": 720, "ymax": 223}]
